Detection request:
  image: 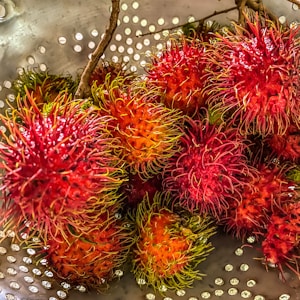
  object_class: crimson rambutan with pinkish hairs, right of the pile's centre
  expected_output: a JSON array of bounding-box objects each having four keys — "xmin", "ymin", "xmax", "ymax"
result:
[{"xmin": 163, "ymin": 117, "xmax": 253, "ymax": 218}]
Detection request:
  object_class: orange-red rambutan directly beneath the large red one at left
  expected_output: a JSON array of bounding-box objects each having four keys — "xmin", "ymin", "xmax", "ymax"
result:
[{"xmin": 43, "ymin": 209, "xmax": 134, "ymax": 292}]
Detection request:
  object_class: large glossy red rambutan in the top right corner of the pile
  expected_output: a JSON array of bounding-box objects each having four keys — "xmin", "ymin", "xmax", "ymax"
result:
[{"xmin": 207, "ymin": 15, "xmax": 300, "ymax": 136}]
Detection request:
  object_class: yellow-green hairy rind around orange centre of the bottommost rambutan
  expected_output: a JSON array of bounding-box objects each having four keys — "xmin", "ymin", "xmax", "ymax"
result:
[{"xmin": 132, "ymin": 192, "xmax": 215, "ymax": 294}]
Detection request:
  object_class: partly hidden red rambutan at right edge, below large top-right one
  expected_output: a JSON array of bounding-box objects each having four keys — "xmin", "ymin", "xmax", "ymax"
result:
[{"xmin": 266, "ymin": 124, "xmax": 300, "ymax": 162}]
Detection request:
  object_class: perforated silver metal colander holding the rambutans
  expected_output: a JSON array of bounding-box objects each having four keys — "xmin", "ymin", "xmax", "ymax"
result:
[{"xmin": 0, "ymin": 0, "xmax": 300, "ymax": 300}]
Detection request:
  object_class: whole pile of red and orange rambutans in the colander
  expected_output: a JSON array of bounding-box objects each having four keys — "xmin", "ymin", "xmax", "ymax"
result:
[{"xmin": 0, "ymin": 11, "xmax": 300, "ymax": 293}]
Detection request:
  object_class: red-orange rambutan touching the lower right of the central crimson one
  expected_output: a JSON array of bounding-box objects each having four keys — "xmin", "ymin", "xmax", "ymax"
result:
[{"xmin": 220, "ymin": 163, "xmax": 295, "ymax": 241}]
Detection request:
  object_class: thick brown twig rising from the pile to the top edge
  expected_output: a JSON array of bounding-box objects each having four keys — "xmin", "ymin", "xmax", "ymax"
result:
[{"xmin": 75, "ymin": 0, "xmax": 120, "ymax": 99}]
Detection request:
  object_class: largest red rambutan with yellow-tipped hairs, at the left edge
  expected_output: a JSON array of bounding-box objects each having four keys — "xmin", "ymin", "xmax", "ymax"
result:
[{"xmin": 0, "ymin": 94, "xmax": 124, "ymax": 240}]
